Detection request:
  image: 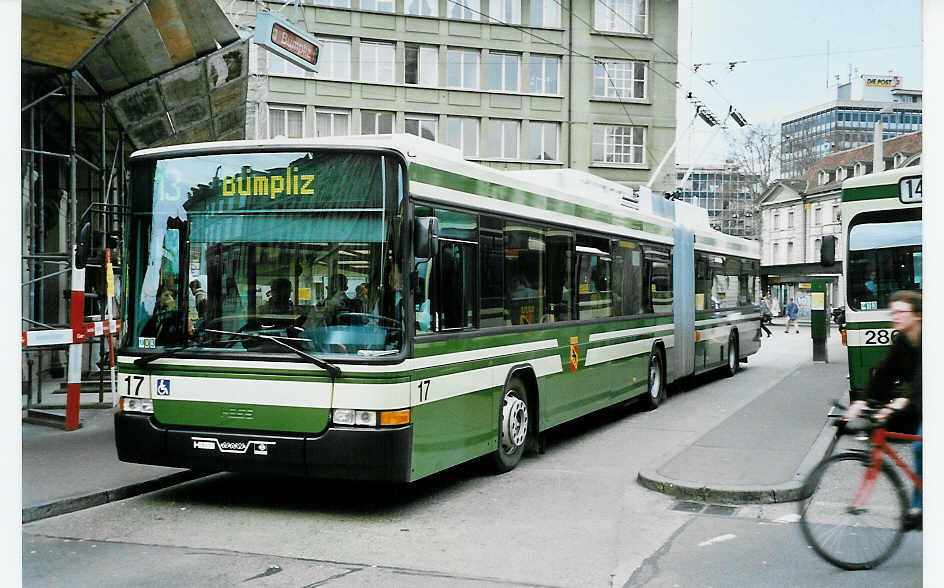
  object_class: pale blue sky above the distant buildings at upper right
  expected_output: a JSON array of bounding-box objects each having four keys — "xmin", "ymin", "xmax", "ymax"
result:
[{"xmin": 676, "ymin": 0, "xmax": 923, "ymax": 164}]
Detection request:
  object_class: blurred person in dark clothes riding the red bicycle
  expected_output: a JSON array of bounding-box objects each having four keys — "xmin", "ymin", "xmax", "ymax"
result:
[{"xmin": 845, "ymin": 290, "xmax": 922, "ymax": 528}]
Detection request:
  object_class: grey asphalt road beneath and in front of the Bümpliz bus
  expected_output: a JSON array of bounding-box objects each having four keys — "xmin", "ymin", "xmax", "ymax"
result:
[{"xmin": 23, "ymin": 335, "xmax": 921, "ymax": 588}]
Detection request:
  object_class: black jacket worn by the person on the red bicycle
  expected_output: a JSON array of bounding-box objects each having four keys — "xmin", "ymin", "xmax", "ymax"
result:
[{"xmin": 860, "ymin": 334, "xmax": 921, "ymax": 433}]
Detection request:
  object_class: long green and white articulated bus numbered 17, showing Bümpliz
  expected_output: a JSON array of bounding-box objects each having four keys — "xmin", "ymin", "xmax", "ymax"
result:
[{"xmin": 115, "ymin": 135, "xmax": 760, "ymax": 482}]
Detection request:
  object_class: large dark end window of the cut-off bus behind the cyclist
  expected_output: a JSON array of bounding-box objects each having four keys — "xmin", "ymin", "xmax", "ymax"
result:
[{"xmin": 846, "ymin": 220, "xmax": 921, "ymax": 310}]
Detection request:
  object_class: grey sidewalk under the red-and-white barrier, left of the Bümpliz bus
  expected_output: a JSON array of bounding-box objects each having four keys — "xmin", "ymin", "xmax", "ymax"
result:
[{"xmin": 22, "ymin": 407, "xmax": 205, "ymax": 523}]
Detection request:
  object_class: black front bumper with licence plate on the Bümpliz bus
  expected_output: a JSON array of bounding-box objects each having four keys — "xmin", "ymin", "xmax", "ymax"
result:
[{"xmin": 115, "ymin": 412, "xmax": 413, "ymax": 482}]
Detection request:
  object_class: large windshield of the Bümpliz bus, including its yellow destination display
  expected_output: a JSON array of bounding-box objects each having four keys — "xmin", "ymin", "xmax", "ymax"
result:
[{"xmin": 123, "ymin": 151, "xmax": 403, "ymax": 356}]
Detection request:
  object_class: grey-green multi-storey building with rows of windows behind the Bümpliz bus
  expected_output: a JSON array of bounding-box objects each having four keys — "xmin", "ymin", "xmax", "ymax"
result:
[{"xmin": 224, "ymin": 0, "xmax": 678, "ymax": 189}]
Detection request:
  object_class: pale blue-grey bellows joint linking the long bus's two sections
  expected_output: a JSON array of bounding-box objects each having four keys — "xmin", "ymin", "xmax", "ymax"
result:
[{"xmin": 670, "ymin": 226, "xmax": 695, "ymax": 381}]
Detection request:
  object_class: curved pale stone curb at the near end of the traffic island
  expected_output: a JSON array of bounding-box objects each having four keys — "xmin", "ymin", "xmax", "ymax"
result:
[{"xmin": 636, "ymin": 421, "xmax": 838, "ymax": 504}]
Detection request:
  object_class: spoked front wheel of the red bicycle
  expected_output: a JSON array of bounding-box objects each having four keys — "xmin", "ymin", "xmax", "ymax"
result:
[{"xmin": 800, "ymin": 453, "xmax": 908, "ymax": 570}]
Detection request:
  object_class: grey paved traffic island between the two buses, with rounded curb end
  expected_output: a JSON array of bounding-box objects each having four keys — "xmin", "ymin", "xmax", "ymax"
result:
[{"xmin": 637, "ymin": 326, "xmax": 849, "ymax": 504}]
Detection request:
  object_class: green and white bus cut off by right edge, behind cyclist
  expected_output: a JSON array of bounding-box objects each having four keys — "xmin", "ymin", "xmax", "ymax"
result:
[{"xmin": 839, "ymin": 165, "xmax": 922, "ymax": 398}]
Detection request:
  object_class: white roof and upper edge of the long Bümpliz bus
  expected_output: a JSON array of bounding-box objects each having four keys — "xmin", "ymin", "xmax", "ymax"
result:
[{"xmin": 131, "ymin": 134, "xmax": 760, "ymax": 258}]
